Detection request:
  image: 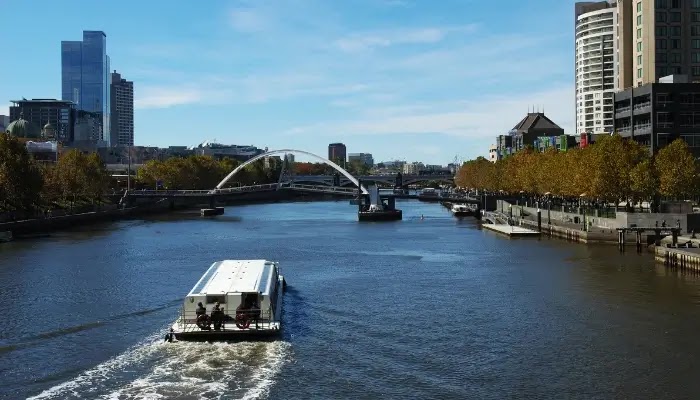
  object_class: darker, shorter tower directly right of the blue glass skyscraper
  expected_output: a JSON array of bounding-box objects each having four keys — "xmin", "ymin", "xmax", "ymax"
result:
[{"xmin": 110, "ymin": 71, "xmax": 134, "ymax": 146}]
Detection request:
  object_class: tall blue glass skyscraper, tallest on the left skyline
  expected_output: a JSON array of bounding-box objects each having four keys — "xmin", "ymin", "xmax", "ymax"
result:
[{"xmin": 61, "ymin": 31, "xmax": 111, "ymax": 144}]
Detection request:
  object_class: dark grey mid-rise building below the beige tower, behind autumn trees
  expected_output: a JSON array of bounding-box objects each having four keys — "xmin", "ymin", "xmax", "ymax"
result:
[{"xmin": 615, "ymin": 75, "xmax": 700, "ymax": 157}]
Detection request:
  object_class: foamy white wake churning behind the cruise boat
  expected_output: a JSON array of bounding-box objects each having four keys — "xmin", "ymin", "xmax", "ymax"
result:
[{"xmin": 30, "ymin": 331, "xmax": 291, "ymax": 400}]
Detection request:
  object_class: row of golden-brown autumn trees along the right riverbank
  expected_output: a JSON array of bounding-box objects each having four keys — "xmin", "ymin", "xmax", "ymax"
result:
[{"xmin": 455, "ymin": 135, "xmax": 698, "ymax": 203}]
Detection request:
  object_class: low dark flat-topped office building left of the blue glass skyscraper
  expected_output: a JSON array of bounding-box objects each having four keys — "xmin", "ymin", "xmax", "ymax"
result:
[{"xmin": 10, "ymin": 99, "xmax": 76, "ymax": 143}]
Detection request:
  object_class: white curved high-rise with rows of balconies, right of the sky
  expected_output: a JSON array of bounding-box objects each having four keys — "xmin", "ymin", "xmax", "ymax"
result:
[{"xmin": 575, "ymin": 1, "xmax": 618, "ymax": 134}]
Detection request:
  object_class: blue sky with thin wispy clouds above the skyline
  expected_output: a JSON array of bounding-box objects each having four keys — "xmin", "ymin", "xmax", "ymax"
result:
[{"xmin": 0, "ymin": 0, "xmax": 574, "ymax": 164}]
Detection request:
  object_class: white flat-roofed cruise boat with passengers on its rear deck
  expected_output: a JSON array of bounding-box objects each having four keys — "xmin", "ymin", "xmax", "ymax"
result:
[{"xmin": 166, "ymin": 260, "xmax": 286, "ymax": 341}]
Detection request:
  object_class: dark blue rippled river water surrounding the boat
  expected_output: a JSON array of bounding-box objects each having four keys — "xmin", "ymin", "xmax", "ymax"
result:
[{"xmin": 0, "ymin": 201, "xmax": 700, "ymax": 399}]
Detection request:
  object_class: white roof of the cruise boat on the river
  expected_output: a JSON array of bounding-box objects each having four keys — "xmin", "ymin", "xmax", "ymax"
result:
[{"xmin": 188, "ymin": 260, "xmax": 276, "ymax": 296}]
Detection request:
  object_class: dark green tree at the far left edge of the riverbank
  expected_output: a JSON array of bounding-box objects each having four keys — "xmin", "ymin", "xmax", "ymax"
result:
[{"xmin": 0, "ymin": 133, "xmax": 43, "ymax": 211}]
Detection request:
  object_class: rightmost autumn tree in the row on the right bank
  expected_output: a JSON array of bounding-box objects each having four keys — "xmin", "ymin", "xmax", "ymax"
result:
[{"xmin": 655, "ymin": 139, "xmax": 697, "ymax": 199}]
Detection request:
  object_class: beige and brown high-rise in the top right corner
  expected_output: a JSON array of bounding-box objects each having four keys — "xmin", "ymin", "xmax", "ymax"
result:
[{"xmin": 618, "ymin": 0, "xmax": 700, "ymax": 89}]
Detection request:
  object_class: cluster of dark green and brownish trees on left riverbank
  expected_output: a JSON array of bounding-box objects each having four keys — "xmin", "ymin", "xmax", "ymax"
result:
[{"xmin": 0, "ymin": 134, "xmax": 109, "ymax": 214}]
